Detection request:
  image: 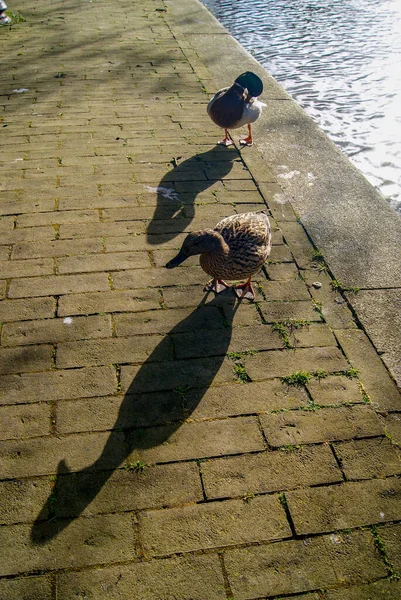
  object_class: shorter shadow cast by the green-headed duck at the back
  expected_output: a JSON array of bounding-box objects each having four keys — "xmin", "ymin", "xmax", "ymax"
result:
[{"xmin": 146, "ymin": 144, "xmax": 239, "ymax": 244}]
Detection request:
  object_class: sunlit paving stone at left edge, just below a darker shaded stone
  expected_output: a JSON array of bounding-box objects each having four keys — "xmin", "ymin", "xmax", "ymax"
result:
[{"xmin": 0, "ymin": 366, "xmax": 117, "ymax": 404}]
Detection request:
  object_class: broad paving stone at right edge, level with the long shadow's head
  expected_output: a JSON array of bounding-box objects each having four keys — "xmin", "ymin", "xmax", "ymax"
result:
[{"xmin": 286, "ymin": 478, "xmax": 401, "ymax": 534}]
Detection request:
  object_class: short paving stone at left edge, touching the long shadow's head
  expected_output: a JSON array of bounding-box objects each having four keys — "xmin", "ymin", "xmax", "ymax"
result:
[{"xmin": 0, "ymin": 478, "xmax": 53, "ymax": 524}]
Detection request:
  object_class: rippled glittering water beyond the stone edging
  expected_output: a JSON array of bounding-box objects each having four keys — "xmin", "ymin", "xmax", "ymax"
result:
[{"xmin": 202, "ymin": 0, "xmax": 401, "ymax": 213}]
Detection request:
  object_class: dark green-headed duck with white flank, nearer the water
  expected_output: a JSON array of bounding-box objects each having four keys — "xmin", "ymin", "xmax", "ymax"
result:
[{"xmin": 207, "ymin": 71, "xmax": 266, "ymax": 146}]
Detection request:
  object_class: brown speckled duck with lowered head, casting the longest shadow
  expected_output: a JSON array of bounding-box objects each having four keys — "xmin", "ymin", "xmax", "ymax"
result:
[{"xmin": 166, "ymin": 211, "xmax": 271, "ymax": 300}]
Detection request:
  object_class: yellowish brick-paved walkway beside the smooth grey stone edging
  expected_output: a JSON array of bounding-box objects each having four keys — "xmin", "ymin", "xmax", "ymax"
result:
[{"xmin": 0, "ymin": 0, "xmax": 401, "ymax": 600}]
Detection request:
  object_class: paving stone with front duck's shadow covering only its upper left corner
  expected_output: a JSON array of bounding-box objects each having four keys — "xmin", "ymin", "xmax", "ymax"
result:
[{"xmin": 129, "ymin": 417, "xmax": 264, "ymax": 463}]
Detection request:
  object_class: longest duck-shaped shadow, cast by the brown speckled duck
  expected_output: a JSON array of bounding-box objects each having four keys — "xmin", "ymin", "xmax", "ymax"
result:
[{"xmin": 31, "ymin": 291, "xmax": 239, "ymax": 545}]
